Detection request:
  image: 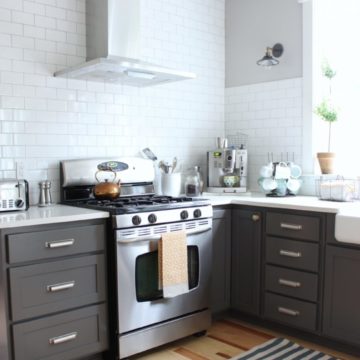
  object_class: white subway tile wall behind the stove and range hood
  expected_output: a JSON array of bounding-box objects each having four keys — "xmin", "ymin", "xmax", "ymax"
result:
[{"xmin": 0, "ymin": 0, "xmax": 224, "ymax": 203}]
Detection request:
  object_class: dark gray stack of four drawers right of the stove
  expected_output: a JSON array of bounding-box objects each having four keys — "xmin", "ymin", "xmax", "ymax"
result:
[{"xmin": 264, "ymin": 210, "xmax": 325, "ymax": 332}]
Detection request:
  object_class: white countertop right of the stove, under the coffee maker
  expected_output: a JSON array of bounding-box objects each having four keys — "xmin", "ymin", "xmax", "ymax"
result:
[{"xmin": 202, "ymin": 193, "xmax": 360, "ymax": 213}]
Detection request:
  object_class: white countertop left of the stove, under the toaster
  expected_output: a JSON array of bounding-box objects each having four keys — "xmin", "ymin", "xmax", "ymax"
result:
[{"xmin": 0, "ymin": 204, "xmax": 109, "ymax": 229}]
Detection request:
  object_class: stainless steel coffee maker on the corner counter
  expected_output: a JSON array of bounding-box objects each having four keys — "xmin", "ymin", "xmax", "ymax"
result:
[{"xmin": 207, "ymin": 148, "xmax": 247, "ymax": 193}]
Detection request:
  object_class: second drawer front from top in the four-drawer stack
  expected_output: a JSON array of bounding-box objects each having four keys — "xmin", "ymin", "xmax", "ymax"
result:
[{"xmin": 266, "ymin": 237, "xmax": 319, "ymax": 272}]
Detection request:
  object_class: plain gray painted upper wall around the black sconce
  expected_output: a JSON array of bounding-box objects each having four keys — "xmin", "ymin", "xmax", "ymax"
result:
[{"xmin": 225, "ymin": 0, "xmax": 302, "ymax": 87}]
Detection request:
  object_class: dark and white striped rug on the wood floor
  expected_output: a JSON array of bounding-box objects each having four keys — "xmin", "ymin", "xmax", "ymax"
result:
[{"xmin": 231, "ymin": 338, "xmax": 336, "ymax": 360}]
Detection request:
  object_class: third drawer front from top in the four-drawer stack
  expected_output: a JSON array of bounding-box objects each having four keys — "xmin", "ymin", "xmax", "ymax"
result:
[{"xmin": 265, "ymin": 265, "xmax": 318, "ymax": 302}]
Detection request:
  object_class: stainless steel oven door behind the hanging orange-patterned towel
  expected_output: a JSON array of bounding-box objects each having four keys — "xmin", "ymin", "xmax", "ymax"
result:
[{"xmin": 116, "ymin": 219, "xmax": 212, "ymax": 334}]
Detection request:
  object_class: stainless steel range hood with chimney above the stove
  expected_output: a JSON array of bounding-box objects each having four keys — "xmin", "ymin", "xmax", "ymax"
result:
[{"xmin": 54, "ymin": 0, "xmax": 195, "ymax": 86}]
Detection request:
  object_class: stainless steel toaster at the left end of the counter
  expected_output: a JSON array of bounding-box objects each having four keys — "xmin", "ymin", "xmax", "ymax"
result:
[{"xmin": 0, "ymin": 179, "xmax": 29, "ymax": 211}]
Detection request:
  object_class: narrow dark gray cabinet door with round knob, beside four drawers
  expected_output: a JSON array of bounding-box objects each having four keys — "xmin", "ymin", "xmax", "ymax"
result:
[{"xmin": 231, "ymin": 209, "xmax": 262, "ymax": 315}]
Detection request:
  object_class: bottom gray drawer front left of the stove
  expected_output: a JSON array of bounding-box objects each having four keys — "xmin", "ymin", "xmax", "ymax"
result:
[{"xmin": 13, "ymin": 305, "xmax": 108, "ymax": 360}]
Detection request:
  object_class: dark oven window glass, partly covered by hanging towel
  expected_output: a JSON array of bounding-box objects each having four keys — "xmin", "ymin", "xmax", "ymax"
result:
[{"xmin": 135, "ymin": 246, "xmax": 199, "ymax": 302}]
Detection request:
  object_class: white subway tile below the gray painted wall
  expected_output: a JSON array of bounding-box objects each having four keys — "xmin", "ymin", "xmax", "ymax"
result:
[{"xmin": 225, "ymin": 78, "xmax": 302, "ymax": 191}]
